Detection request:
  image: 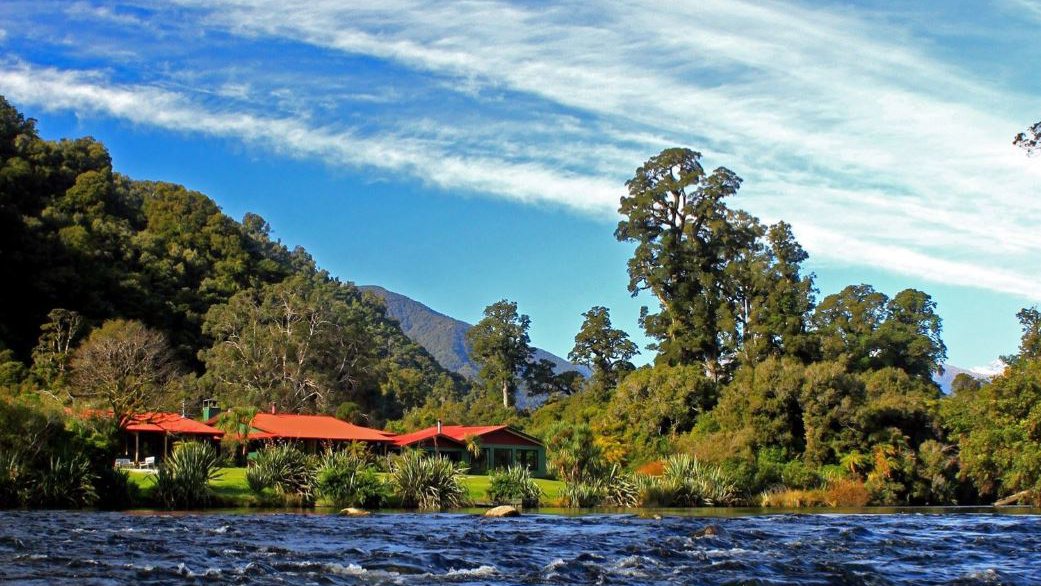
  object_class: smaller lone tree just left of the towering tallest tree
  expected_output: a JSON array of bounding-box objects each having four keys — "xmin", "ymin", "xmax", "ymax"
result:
[{"xmin": 567, "ymin": 305, "xmax": 639, "ymax": 388}]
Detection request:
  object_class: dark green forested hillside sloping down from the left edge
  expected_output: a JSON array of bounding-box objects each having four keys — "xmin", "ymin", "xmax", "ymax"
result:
[{"xmin": 0, "ymin": 100, "xmax": 461, "ymax": 421}]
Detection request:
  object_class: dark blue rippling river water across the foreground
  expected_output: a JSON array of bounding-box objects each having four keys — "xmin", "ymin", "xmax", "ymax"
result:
[{"xmin": 0, "ymin": 511, "xmax": 1041, "ymax": 586}]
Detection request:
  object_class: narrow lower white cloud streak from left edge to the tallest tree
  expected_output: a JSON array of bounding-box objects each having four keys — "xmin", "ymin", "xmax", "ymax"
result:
[{"xmin": 0, "ymin": 66, "xmax": 618, "ymax": 212}]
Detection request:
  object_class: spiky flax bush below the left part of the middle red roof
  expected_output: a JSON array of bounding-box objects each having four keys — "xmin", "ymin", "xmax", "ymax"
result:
[{"xmin": 246, "ymin": 444, "xmax": 318, "ymax": 506}]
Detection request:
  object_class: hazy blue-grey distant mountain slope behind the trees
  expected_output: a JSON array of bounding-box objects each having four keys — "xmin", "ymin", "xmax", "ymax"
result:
[{"xmin": 358, "ymin": 285, "xmax": 588, "ymax": 378}]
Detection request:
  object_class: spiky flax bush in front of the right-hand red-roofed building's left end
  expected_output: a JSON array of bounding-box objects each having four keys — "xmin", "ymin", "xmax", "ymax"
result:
[{"xmin": 390, "ymin": 452, "xmax": 466, "ymax": 510}]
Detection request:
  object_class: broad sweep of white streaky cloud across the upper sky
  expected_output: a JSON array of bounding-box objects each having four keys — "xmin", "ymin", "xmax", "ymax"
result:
[{"xmin": 0, "ymin": 0, "xmax": 1041, "ymax": 300}]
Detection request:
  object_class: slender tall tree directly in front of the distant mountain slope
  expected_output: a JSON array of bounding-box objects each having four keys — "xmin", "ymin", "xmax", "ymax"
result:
[{"xmin": 466, "ymin": 299, "xmax": 534, "ymax": 407}]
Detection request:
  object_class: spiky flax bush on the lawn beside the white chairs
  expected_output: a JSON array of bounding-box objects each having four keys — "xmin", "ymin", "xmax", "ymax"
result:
[{"xmin": 155, "ymin": 441, "xmax": 221, "ymax": 509}]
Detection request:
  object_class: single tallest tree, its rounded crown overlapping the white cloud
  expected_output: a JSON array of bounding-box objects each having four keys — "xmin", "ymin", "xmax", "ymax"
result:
[{"xmin": 615, "ymin": 148, "xmax": 756, "ymax": 378}]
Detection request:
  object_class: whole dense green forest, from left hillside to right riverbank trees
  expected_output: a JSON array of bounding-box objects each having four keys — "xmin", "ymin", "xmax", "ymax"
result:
[{"xmin": 0, "ymin": 99, "xmax": 1041, "ymax": 505}]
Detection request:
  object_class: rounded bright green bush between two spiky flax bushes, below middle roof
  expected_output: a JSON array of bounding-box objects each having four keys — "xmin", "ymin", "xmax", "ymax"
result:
[{"xmin": 315, "ymin": 452, "xmax": 387, "ymax": 509}]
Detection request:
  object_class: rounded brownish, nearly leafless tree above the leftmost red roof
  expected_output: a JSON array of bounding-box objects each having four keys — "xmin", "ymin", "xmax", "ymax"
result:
[{"xmin": 69, "ymin": 320, "xmax": 177, "ymax": 424}]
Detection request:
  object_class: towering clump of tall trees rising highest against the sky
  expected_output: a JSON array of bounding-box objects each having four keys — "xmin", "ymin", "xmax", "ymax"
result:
[{"xmin": 615, "ymin": 149, "xmax": 814, "ymax": 381}]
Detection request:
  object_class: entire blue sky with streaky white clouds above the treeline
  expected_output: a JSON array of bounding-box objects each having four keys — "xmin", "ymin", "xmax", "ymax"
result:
[{"xmin": 0, "ymin": 0, "xmax": 1041, "ymax": 367}]
